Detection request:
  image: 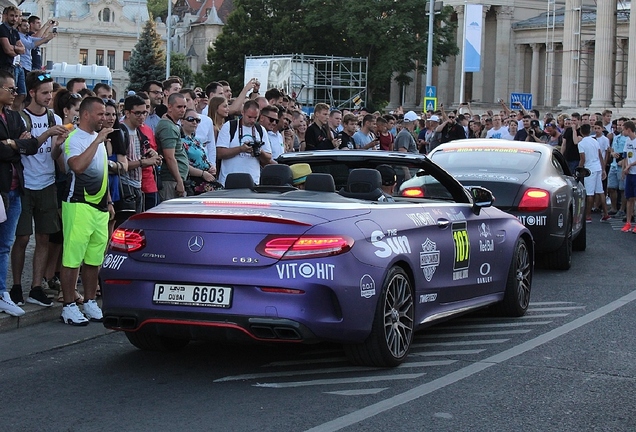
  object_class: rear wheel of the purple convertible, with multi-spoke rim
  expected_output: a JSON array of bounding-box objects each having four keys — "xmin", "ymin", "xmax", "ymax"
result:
[{"xmin": 345, "ymin": 266, "xmax": 415, "ymax": 367}]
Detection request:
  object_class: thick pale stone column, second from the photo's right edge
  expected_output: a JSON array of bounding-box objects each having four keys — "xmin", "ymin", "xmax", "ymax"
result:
[{"xmin": 590, "ymin": 0, "xmax": 620, "ymax": 109}]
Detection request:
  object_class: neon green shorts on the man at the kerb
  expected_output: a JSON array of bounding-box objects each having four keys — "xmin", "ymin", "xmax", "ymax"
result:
[{"xmin": 62, "ymin": 202, "xmax": 110, "ymax": 268}]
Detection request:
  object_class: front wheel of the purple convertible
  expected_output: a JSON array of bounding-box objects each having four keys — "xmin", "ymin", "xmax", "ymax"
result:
[{"xmin": 495, "ymin": 238, "xmax": 533, "ymax": 317}]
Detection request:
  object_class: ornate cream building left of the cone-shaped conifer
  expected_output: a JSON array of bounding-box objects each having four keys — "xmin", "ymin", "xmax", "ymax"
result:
[{"xmin": 20, "ymin": 0, "xmax": 150, "ymax": 97}]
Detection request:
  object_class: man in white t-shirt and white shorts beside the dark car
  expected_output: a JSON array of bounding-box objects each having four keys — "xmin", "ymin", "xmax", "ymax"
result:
[{"xmin": 578, "ymin": 124, "xmax": 610, "ymax": 223}]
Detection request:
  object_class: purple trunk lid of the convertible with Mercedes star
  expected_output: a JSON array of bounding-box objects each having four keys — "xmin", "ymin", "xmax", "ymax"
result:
[{"xmin": 115, "ymin": 199, "xmax": 370, "ymax": 268}]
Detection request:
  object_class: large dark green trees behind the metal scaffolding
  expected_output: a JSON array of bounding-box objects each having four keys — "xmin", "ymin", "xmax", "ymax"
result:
[{"xmin": 200, "ymin": 0, "xmax": 459, "ymax": 102}]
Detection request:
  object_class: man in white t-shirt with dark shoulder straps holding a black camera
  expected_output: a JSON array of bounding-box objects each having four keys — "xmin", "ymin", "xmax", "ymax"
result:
[{"xmin": 216, "ymin": 100, "xmax": 275, "ymax": 185}]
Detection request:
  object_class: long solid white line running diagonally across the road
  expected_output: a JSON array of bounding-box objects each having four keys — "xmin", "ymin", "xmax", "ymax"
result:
[{"xmin": 307, "ymin": 290, "xmax": 636, "ymax": 432}]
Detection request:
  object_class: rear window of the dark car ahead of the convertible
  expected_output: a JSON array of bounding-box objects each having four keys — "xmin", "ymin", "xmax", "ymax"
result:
[{"xmin": 431, "ymin": 147, "xmax": 541, "ymax": 173}]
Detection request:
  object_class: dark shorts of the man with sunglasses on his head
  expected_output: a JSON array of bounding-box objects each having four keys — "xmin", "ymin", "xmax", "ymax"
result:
[{"xmin": 15, "ymin": 184, "xmax": 60, "ymax": 236}]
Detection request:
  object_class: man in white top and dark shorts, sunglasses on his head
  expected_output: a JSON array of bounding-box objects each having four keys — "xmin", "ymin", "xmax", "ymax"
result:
[{"xmin": 11, "ymin": 71, "xmax": 68, "ymax": 307}]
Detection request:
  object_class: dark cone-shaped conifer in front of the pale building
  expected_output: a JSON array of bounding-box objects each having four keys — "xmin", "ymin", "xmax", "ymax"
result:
[{"xmin": 125, "ymin": 16, "xmax": 166, "ymax": 90}]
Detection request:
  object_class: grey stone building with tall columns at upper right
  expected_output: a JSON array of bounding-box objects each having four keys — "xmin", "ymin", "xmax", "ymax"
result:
[{"xmin": 389, "ymin": 0, "xmax": 636, "ymax": 112}]
